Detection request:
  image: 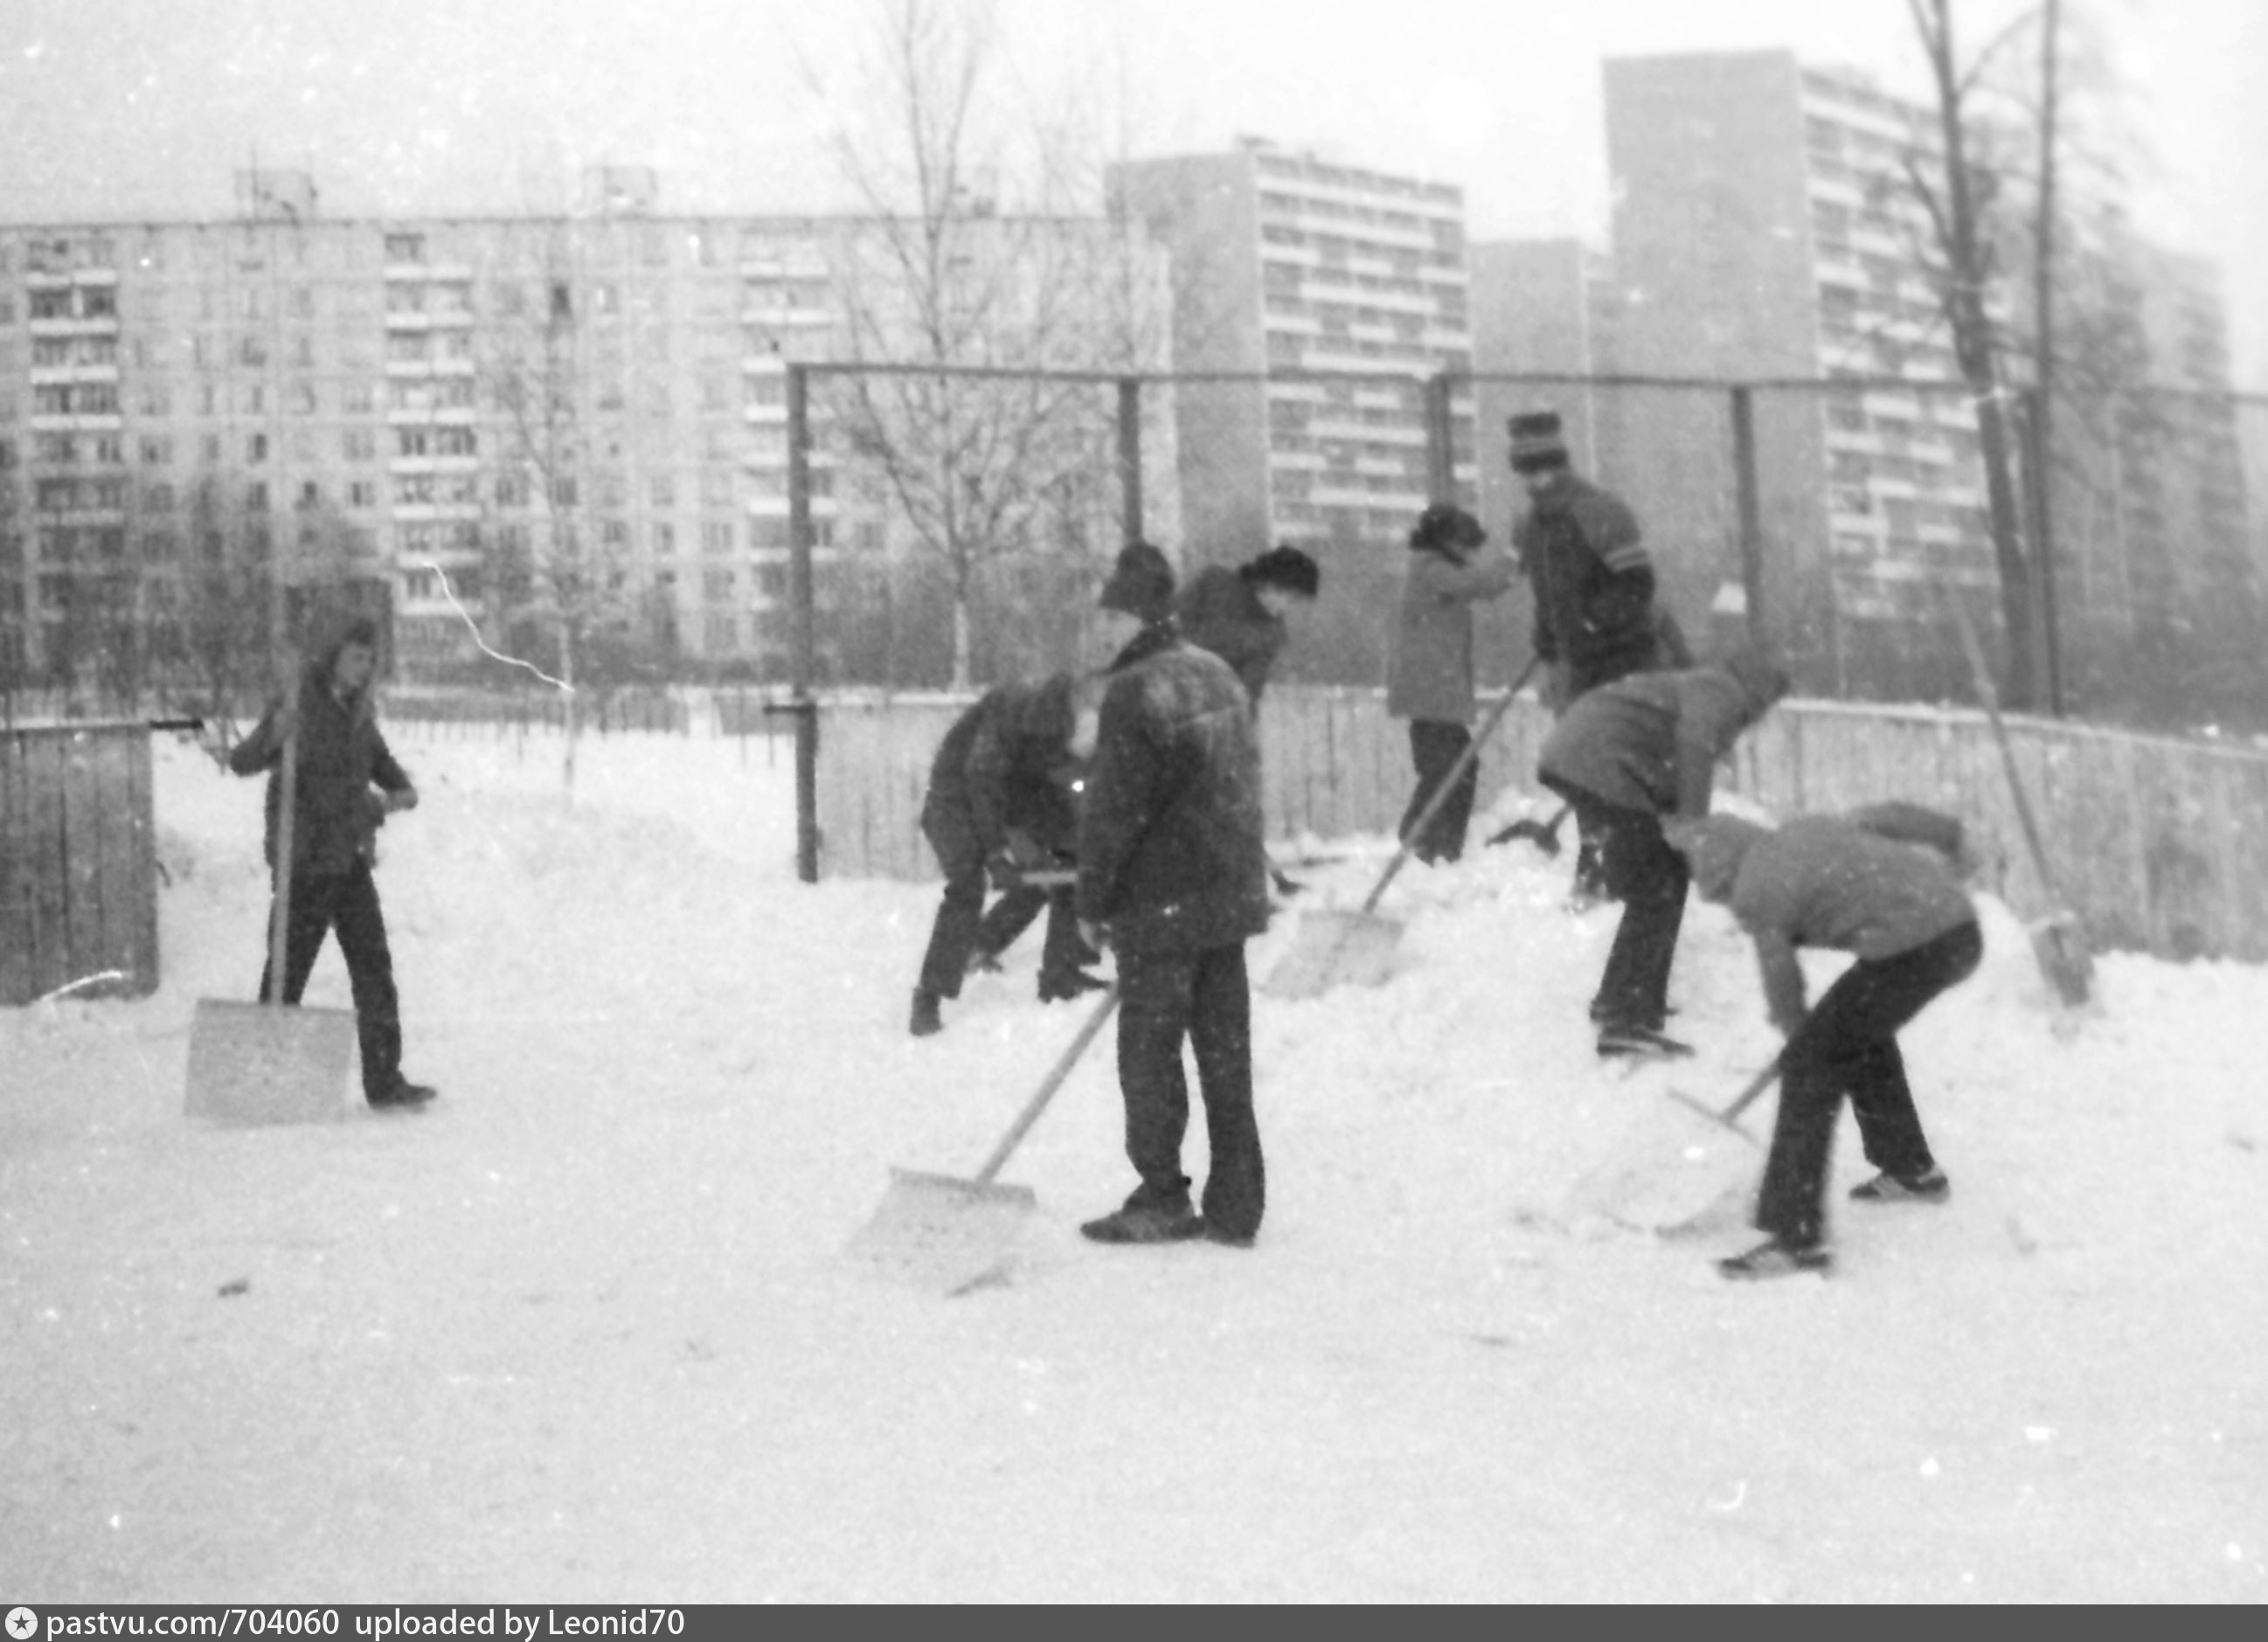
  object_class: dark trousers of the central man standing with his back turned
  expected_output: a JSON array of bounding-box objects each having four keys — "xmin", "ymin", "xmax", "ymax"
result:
[{"xmin": 1118, "ymin": 941, "xmax": 1268, "ymax": 1236}]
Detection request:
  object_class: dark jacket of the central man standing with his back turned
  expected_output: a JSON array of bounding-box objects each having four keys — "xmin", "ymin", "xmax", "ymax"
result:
[{"xmin": 1078, "ymin": 624, "xmax": 1268, "ymax": 953}]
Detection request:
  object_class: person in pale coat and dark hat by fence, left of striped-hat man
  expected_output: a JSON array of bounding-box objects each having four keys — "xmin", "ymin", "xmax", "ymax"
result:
[{"xmin": 1386, "ymin": 502, "xmax": 1513, "ymax": 864}]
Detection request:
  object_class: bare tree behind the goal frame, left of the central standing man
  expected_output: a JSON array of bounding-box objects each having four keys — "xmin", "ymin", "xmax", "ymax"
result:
[{"xmin": 807, "ymin": 0, "xmax": 1163, "ymax": 687}]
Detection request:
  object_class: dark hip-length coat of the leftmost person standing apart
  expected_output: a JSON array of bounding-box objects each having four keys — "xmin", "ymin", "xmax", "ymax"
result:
[{"xmin": 229, "ymin": 653, "xmax": 411, "ymax": 873}]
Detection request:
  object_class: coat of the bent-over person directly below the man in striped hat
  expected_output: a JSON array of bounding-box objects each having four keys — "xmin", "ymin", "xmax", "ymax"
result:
[{"xmin": 1536, "ymin": 662, "xmax": 1785, "ymax": 821}]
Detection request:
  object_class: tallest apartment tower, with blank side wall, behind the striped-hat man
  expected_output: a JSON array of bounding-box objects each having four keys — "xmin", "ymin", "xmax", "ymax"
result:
[{"xmin": 1601, "ymin": 50, "xmax": 1991, "ymax": 692}]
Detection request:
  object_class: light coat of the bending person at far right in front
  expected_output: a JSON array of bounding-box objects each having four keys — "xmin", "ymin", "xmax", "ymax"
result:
[{"xmin": 1688, "ymin": 805, "xmax": 1975, "ymax": 1028}]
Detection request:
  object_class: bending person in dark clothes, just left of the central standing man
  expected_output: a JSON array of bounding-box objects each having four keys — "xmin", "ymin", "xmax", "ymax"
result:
[{"xmin": 907, "ymin": 674, "xmax": 1105, "ymax": 1039}]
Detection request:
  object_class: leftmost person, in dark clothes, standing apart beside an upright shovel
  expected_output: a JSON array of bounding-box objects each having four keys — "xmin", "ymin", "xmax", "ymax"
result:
[{"xmin": 229, "ymin": 617, "xmax": 433, "ymax": 1112}]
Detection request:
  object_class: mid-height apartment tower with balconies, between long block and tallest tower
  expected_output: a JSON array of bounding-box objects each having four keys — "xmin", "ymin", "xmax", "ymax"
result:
[{"xmin": 1112, "ymin": 138, "xmax": 1474, "ymax": 682}]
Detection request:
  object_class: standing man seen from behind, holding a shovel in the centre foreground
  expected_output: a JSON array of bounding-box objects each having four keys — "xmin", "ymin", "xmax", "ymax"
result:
[{"xmin": 1075, "ymin": 542, "xmax": 1268, "ymax": 1247}]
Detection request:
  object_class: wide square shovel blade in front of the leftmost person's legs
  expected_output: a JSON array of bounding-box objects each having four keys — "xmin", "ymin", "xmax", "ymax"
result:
[{"xmin": 186, "ymin": 998, "xmax": 354, "ymax": 1125}]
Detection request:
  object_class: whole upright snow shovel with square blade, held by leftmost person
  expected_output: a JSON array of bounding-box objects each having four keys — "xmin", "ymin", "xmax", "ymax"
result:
[{"xmin": 186, "ymin": 655, "xmax": 354, "ymax": 1125}]
